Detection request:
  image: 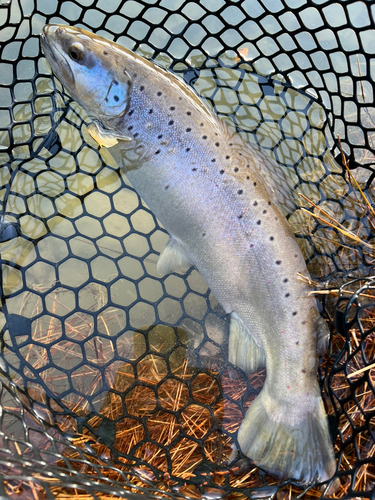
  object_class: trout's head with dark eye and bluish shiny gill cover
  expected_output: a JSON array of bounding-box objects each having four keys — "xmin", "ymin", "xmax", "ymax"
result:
[{"xmin": 41, "ymin": 24, "xmax": 132, "ymax": 124}]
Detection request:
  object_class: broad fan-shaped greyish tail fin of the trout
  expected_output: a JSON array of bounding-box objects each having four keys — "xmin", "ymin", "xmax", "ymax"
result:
[{"xmin": 238, "ymin": 385, "xmax": 336, "ymax": 483}]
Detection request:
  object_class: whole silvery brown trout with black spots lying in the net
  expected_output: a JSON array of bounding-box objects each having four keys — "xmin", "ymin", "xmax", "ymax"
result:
[{"xmin": 41, "ymin": 25, "xmax": 336, "ymax": 483}]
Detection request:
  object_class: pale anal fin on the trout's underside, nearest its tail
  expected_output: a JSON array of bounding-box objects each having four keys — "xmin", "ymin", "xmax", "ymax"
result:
[{"xmin": 228, "ymin": 313, "xmax": 266, "ymax": 373}]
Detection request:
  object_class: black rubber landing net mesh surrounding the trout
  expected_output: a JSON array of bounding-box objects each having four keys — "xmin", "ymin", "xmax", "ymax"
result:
[{"xmin": 0, "ymin": 0, "xmax": 375, "ymax": 500}]
